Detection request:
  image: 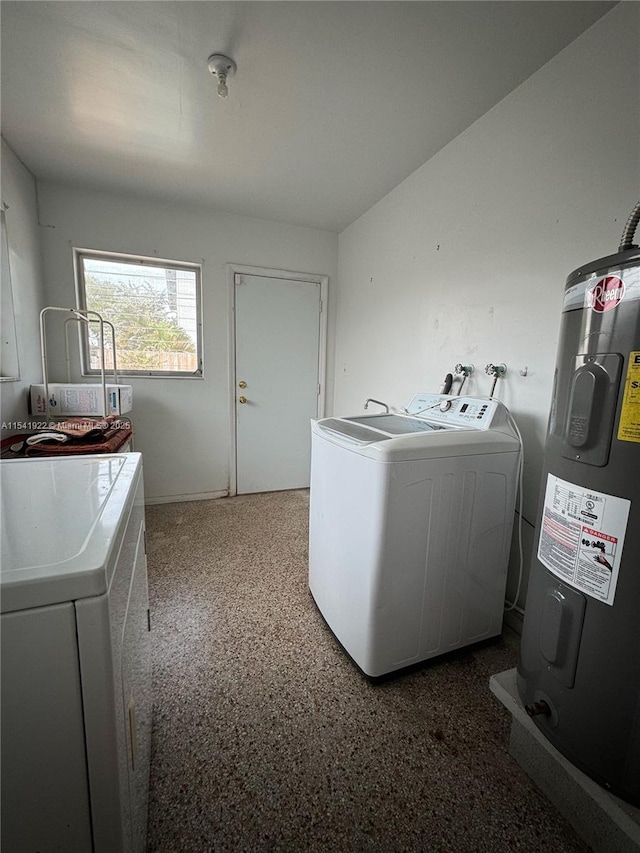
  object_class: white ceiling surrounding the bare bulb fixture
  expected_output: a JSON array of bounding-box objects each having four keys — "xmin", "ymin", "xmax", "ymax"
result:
[{"xmin": 0, "ymin": 0, "xmax": 615, "ymax": 231}]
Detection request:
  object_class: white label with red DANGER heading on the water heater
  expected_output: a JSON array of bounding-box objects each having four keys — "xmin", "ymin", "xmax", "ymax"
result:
[{"xmin": 538, "ymin": 474, "xmax": 631, "ymax": 605}]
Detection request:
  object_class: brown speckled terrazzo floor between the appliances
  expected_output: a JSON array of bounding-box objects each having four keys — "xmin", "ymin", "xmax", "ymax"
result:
[{"xmin": 147, "ymin": 491, "xmax": 589, "ymax": 853}]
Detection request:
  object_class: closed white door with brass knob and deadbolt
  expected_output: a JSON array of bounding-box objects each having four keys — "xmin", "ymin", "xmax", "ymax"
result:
[{"xmin": 234, "ymin": 274, "xmax": 322, "ymax": 494}]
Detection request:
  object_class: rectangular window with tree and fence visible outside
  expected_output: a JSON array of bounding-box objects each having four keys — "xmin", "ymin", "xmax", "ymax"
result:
[{"xmin": 75, "ymin": 249, "xmax": 202, "ymax": 376}]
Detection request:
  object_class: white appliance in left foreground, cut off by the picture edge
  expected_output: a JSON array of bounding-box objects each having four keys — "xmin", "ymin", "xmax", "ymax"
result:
[{"xmin": 0, "ymin": 453, "xmax": 152, "ymax": 853}]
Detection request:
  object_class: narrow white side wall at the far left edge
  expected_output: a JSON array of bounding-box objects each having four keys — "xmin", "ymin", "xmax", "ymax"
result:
[{"xmin": 0, "ymin": 140, "xmax": 44, "ymax": 435}]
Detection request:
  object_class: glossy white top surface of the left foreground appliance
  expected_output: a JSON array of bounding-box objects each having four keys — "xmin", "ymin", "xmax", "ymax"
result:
[{"xmin": 0, "ymin": 453, "xmax": 141, "ymax": 612}]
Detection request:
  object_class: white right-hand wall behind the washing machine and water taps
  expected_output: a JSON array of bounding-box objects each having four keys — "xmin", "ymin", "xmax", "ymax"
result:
[{"xmin": 334, "ymin": 3, "xmax": 640, "ymax": 603}]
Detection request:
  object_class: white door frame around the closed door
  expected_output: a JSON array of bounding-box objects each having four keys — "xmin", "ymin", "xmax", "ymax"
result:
[{"xmin": 227, "ymin": 263, "xmax": 329, "ymax": 496}]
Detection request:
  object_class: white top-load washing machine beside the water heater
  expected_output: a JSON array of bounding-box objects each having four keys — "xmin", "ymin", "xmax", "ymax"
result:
[{"xmin": 309, "ymin": 394, "xmax": 520, "ymax": 678}]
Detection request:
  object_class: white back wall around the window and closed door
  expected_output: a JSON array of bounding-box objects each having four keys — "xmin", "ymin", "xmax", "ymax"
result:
[{"xmin": 38, "ymin": 183, "xmax": 338, "ymax": 500}]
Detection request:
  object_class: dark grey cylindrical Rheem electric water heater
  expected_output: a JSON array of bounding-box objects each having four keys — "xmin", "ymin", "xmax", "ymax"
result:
[{"xmin": 518, "ymin": 202, "xmax": 640, "ymax": 805}]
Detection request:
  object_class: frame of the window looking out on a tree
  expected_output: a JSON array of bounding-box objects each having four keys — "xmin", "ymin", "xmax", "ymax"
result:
[{"xmin": 73, "ymin": 247, "xmax": 204, "ymax": 381}]
